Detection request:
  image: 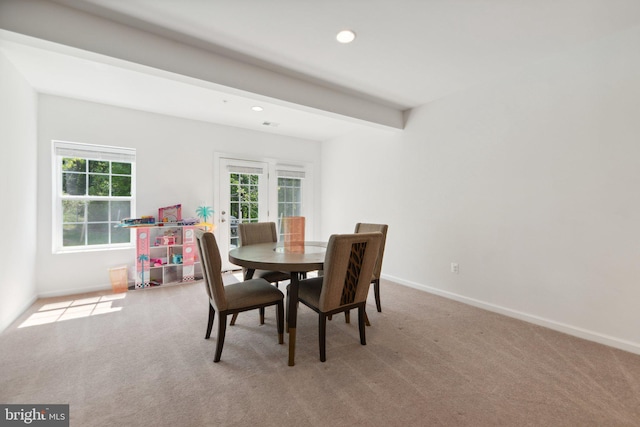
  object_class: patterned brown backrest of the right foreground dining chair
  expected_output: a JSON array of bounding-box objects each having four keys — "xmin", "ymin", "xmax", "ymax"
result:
[{"xmin": 318, "ymin": 232, "xmax": 382, "ymax": 312}]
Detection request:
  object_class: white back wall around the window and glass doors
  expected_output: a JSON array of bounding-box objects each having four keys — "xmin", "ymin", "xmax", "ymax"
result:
[{"xmin": 36, "ymin": 95, "xmax": 320, "ymax": 296}]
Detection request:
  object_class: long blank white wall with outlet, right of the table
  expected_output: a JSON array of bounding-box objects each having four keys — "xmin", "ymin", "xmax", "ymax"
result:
[{"xmin": 322, "ymin": 27, "xmax": 640, "ymax": 353}]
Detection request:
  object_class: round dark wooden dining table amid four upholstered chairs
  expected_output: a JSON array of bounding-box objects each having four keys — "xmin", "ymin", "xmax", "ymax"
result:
[{"xmin": 229, "ymin": 242, "xmax": 327, "ymax": 366}]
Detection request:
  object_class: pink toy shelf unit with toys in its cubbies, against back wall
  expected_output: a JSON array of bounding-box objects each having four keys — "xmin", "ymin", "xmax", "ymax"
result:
[{"xmin": 134, "ymin": 223, "xmax": 202, "ymax": 289}]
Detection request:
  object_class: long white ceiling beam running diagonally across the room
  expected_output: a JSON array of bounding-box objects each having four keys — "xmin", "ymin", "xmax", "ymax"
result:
[{"xmin": 0, "ymin": 0, "xmax": 404, "ymax": 129}]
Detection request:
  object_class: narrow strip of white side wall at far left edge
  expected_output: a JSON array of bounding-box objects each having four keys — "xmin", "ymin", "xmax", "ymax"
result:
[{"xmin": 0, "ymin": 50, "xmax": 37, "ymax": 331}]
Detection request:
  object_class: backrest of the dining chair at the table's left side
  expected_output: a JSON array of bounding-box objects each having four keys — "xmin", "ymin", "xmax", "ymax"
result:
[{"xmin": 196, "ymin": 230, "xmax": 227, "ymax": 310}]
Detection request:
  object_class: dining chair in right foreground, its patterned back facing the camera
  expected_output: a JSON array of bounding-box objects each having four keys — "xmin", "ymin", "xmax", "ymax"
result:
[{"xmin": 294, "ymin": 232, "xmax": 382, "ymax": 362}]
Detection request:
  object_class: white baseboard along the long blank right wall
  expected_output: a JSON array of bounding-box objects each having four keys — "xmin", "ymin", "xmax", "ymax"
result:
[{"xmin": 382, "ymin": 274, "xmax": 640, "ymax": 354}]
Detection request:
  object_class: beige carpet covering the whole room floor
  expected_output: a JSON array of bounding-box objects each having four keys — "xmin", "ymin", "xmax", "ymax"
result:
[{"xmin": 0, "ymin": 281, "xmax": 640, "ymax": 427}]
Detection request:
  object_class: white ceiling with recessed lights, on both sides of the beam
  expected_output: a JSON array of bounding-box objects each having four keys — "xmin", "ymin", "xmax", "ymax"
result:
[{"xmin": 0, "ymin": 0, "xmax": 640, "ymax": 140}]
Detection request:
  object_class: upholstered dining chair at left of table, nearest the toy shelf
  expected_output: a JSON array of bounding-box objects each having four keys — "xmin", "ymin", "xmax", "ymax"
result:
[{"xmin": 196, "ymin": 230, "xmax": 284, "ymax": 363}]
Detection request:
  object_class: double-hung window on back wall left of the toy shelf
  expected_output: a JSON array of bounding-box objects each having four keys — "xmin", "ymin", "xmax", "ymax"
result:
[{"xmin": 53, "ymin": 141, "xmax": 136, "ymax": 252}]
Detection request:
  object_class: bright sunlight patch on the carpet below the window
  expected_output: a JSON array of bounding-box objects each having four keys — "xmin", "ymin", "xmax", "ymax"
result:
[{"xmin": 18, "ymin": 292, "xmax": 127, "ymax": 328}]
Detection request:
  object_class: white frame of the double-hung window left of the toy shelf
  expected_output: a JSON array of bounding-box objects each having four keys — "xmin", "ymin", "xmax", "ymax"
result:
[{"xmin": 51, "ymin": 140, "xmax": 136, "ymax": 254}]
